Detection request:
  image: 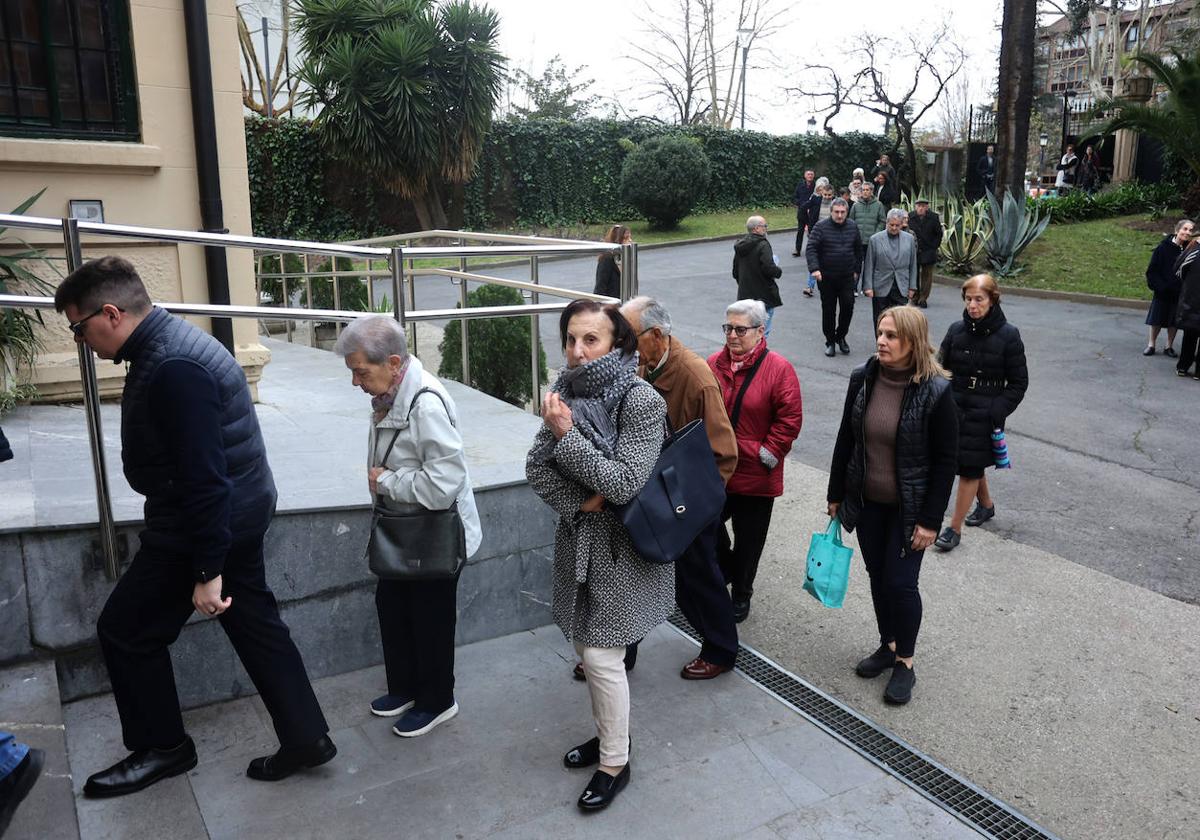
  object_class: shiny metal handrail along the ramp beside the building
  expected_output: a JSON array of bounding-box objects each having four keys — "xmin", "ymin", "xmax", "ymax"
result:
[{"xmin": 0, "ymin": 214, "xmax": 637, "ymax": 580}]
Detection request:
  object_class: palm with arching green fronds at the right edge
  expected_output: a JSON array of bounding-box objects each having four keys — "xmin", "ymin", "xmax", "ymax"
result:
[{"xmin": 1096, "ymin": 47, "xmax": 1200, "ymax": 210}]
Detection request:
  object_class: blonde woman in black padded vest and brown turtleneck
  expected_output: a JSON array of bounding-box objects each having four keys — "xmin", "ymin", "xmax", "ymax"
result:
[{"xmin": 826, "ymin": 306, "xmax": 958, "ymax": 704}]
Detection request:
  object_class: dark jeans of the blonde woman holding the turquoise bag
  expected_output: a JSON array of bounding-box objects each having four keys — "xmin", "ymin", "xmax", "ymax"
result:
[{"xmin": 857, "ymin": 502, "xmax": 925, "ymax": 656}]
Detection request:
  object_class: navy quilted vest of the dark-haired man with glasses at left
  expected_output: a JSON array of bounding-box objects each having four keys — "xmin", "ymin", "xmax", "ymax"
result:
[{"xmin": 118, "ymin": 307, "xmax": 276, "ymax": 539}]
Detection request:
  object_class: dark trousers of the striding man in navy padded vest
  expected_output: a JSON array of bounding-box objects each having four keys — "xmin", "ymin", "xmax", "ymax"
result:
[{"xmin": 96, "ymin": 536, "xmax": 329, "ymax": 750}]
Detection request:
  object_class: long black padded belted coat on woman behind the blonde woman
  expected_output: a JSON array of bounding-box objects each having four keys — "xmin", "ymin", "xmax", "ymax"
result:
[{"xmin": 940, "ymin": 304, "xmax": 1030, "ymax": 467}]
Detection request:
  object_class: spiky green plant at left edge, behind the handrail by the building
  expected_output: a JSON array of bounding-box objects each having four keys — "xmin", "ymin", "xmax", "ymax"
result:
[{"xmin": 0, "ymin": 188, "xmax": 61, "ymax": 389}]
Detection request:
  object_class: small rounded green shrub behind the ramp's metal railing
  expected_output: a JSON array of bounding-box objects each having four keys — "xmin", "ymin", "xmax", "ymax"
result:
[{"xmin": 438, "ymin": 283, "xmax": 547, "ymax": 406}]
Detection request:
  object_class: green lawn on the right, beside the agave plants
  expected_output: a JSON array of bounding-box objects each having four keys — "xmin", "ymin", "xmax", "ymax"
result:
[{"xmin": 1004, "ymin": 211, "xmax": 1178, "ymax": 300}]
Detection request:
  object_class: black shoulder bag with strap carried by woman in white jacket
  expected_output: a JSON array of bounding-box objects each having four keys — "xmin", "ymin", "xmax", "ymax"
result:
[{"xmin": 367, "ymin": 388, "xmax": 467, "ymax": 581}]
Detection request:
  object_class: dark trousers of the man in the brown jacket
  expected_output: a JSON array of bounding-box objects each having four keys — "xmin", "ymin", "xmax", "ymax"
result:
[{"xmin": 676, "ymin": 520, "xmax": 738, "ymax": 667}]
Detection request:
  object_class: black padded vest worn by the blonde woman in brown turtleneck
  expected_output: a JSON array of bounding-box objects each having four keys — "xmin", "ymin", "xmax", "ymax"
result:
[{"xmin": 838, "ymin": 359, "xmax": 950, "ymax": 545}]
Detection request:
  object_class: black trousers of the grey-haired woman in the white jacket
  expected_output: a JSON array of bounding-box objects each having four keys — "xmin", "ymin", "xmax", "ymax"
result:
[{"xmin": 376, "ymin": 575, "xmax": 458, "ymax": 712}]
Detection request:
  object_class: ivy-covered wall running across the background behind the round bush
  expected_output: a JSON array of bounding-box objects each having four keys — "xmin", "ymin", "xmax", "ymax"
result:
[{"xmin": 246, "ymin": 118, "xmax": 890, "ymax": 240}]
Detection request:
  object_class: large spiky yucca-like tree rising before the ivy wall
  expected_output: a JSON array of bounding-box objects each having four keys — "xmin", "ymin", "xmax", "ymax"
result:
[{"xmin": 295, "ymin": 0, "xmax": 504, "ymax": 229}]
